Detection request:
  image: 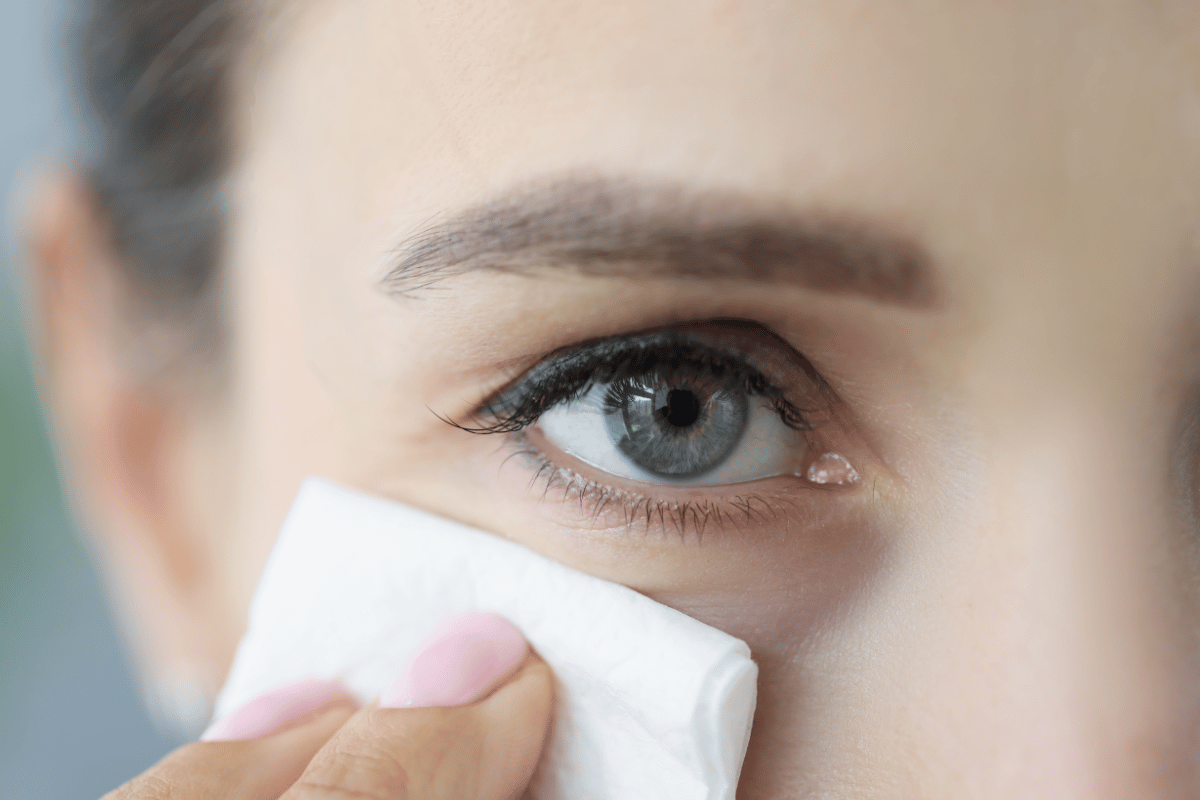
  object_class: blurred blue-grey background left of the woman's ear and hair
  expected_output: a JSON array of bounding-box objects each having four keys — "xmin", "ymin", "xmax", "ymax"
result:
[{"xmin": 0, "ymin": 0, "xmax": 174, "ymax": 800}]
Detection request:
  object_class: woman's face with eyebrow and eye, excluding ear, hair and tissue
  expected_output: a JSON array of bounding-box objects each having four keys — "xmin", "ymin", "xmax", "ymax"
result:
[{"xmin": 44, "ymin": 0, "xmax": 1200, "ymax": 799}]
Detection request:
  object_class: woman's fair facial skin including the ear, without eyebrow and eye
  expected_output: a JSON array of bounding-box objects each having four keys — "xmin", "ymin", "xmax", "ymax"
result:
[{"xmin": 21, "ymin": 0, "xmax": 1200, "ymax": 800}]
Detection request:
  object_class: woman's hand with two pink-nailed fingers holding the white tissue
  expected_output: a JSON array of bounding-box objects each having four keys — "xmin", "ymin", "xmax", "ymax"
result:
[{"xmin": 106, "ymin": 614, "xmax": 553, "ymax": 800}]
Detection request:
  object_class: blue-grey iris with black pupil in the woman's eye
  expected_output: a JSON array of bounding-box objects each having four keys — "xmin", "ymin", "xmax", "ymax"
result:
[{"xmin": 605, "ymin": 379, "xmax": 750, "ymax": 480}]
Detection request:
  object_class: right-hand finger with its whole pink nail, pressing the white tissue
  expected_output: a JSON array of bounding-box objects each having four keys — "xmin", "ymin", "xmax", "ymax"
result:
[{"xmin": 283, "ymin": 613, "xmax": 553, "ymax": 800}]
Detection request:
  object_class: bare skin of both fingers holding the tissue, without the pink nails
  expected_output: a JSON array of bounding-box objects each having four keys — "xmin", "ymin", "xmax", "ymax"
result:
[{"xmin": 104, "ymin": 656, "xmax": 552, "ymax": 800}]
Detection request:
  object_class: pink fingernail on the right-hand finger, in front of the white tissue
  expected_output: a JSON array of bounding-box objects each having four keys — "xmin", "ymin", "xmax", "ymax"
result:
[{"xmin": 379, "ymin": 612, "xmax": 529, "ymax": 709}]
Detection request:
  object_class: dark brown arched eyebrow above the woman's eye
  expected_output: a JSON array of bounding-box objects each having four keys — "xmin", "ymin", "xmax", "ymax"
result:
[{"xmin": 383, "ymin": 178, "xmax": 937, "ymax": 308}]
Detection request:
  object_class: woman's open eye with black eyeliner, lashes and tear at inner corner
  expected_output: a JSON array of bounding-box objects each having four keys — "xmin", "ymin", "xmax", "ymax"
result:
[{"xmin": 446, "ymin": 320, "xmax": 859, "ymax": 532}]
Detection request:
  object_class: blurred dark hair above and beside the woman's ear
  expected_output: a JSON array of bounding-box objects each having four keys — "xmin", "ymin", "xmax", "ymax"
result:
[{"xmin": 79, "ymin": 0, "xmax": 245, "ymax": 362}]
